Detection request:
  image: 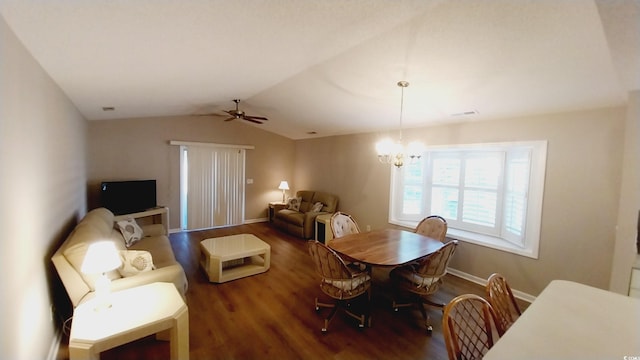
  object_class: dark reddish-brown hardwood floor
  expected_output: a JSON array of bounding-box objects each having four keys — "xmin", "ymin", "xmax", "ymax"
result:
[{"xmin": 58, "ymin": 223, "xmax": 527, "ymax": 360}]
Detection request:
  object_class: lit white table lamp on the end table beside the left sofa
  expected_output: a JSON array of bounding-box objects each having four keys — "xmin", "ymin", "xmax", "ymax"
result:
[{"xmin": 80, "ymin": 241, "xmax": 122, "ymax": 311}]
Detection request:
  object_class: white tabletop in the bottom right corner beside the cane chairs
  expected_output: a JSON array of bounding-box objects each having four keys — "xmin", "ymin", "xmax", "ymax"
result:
[{"xmin": 484, "ymin": 280, "xmax": 640, "ymax": 360}]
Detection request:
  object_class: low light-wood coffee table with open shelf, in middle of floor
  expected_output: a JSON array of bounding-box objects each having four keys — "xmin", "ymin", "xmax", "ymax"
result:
[{"xmin": 200, "ymin": 234, "xmax": 271, "ymax": 283}]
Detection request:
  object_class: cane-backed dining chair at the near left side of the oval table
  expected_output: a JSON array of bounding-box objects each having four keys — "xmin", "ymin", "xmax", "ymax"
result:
[{"xmin": 308, "ymin": 240, "xmax": 371, "ymax": 332}]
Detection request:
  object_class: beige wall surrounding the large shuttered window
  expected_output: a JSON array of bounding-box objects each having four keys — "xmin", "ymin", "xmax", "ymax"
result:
[{"xmin": 295, "ymin": 108, "xmax": 625, "ymax": 295}]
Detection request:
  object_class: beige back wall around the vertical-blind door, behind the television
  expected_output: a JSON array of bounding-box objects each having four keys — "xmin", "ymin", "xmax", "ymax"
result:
[{"xmin": 87, "ymin": 116, "xmax": 294, "ymax": 229}]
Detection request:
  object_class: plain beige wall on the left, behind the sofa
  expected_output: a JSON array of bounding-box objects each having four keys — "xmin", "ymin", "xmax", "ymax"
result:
[{"xmin": 0, "ymin": 17, "xmax": 86, "ymax": 359}]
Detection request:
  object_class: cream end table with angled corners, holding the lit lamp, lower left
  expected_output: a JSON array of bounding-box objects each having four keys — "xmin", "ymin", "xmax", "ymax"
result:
[{"xmin": 69, "ymin": 282, "xmax": 189, "ymax": 360}]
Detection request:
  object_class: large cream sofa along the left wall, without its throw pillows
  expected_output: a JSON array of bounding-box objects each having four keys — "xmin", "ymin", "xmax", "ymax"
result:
[{"xmin": 51, "ymin": 208, "xmax": 187, "ymax": 308}]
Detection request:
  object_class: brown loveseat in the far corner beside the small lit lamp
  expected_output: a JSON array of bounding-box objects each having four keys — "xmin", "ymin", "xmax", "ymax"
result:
[{"xmin": 273, "ymin": 190, "xmax": 338, "ymax": 239}]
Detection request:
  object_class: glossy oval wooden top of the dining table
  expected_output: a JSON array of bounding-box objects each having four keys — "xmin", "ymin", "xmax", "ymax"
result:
[{"xmin": 327, "ymin": 229, "xmax": 444, "ymax": 267}]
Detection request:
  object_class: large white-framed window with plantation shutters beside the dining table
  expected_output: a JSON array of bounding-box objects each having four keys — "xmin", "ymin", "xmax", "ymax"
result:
[{"xmin": 389, "ymin": 141, "xmax": 547, "ymax": 258}]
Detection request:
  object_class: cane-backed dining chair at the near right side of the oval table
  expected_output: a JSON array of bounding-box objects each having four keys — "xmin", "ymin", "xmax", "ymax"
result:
[{"xmin": 389, "ymin": 240, "xmax": 458, "ymax": 334}]
